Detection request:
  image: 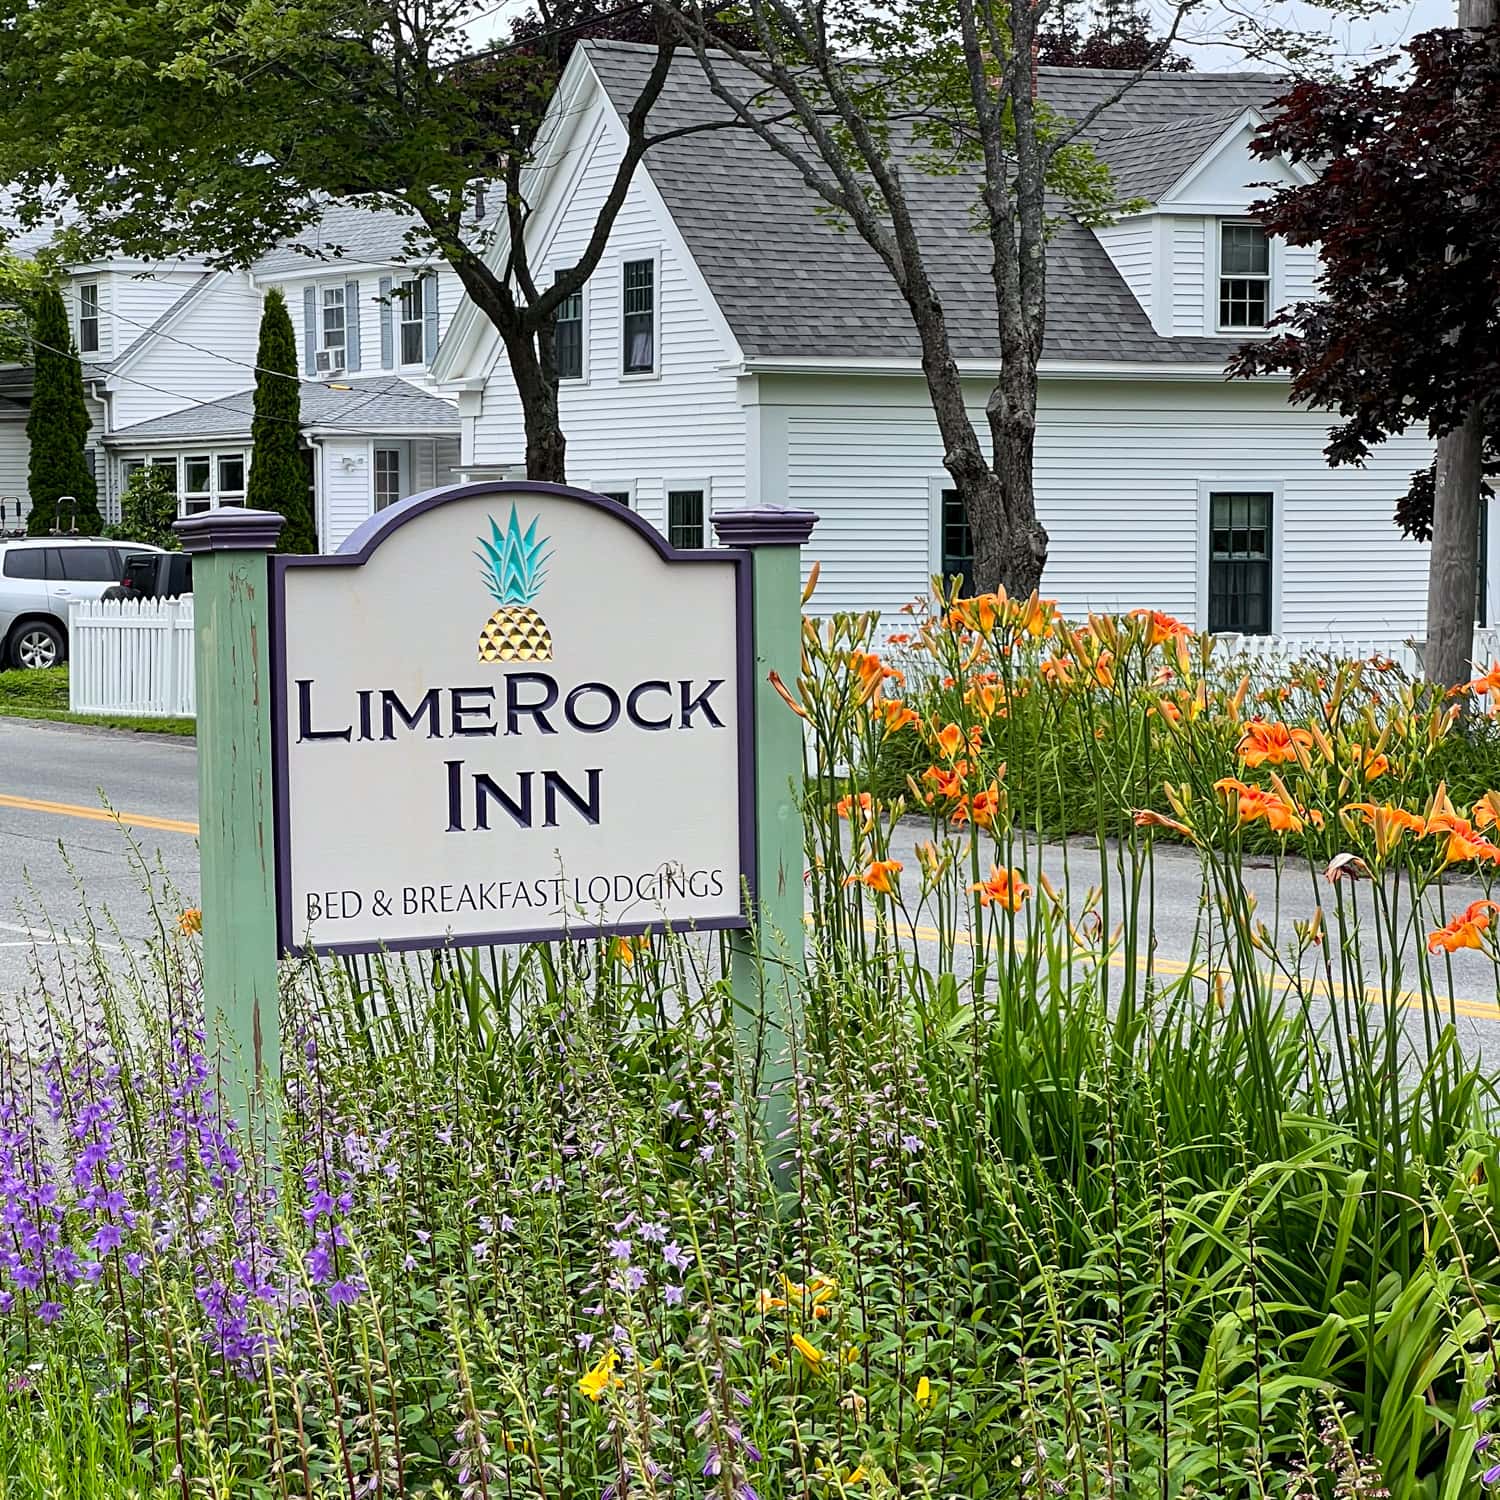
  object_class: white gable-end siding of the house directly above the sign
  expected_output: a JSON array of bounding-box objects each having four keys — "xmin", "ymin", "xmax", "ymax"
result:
[{"xmin": 464, "ymin": 114, "xmax": 746, "ymax": 527}]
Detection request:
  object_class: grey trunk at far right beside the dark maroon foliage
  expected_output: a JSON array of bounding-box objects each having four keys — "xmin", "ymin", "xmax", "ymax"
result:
[{"xmin": 1422, "ymin": 0, "xmax": 1500, "ymax": 687}]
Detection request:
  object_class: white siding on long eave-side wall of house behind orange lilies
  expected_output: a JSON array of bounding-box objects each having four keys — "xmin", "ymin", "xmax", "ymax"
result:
[{"xmin": 761, "ymin": 378, "xmax": 1431, "ymax": 639}]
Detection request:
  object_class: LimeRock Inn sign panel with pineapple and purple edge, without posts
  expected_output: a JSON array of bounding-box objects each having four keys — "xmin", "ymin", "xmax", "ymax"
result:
[{"xmin": 272, "ymin": 485, "xmax": 755, "ymax": 953}]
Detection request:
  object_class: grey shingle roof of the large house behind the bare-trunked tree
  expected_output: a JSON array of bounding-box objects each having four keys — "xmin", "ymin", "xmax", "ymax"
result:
[{"xmin": 584, "ymin": 42, "xmax": 1284, "ymax": 363}]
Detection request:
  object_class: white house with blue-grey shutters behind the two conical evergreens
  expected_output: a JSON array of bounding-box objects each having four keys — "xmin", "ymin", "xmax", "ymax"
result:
[{"xmin": 0, "ymin": 204, "xmax": 459, "ymax": 549}]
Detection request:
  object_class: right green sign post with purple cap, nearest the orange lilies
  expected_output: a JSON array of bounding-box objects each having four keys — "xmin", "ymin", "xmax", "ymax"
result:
[{"xmin": 714, "ymin": 507, "xmax": 818, "ymax": 1160}]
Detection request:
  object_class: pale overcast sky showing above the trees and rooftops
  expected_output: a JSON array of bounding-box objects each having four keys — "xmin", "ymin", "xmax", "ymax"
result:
[{"xmin": 467, "ymin": 0, "xmax": 1455, "ymax": 71}]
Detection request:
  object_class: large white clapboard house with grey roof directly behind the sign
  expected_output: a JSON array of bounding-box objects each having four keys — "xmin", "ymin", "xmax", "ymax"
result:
[{"xmin": 434, "ymin": 42, "xmax": 1464, "ymax": 641}]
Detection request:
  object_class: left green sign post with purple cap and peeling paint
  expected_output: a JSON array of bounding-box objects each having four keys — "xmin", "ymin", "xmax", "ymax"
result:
[{"xmin": 174, "ymin": 506, "xmax": 285, "ymax": 1148}]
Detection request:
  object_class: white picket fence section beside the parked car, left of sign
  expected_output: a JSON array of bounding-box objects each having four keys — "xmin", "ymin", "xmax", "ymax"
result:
[{"xmin": 68, "ymin": 596, "xmax": 197, "ymax": 717}]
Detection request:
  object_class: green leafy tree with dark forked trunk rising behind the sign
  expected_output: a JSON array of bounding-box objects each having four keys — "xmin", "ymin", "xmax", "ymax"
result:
[{"xmin": 0, "ymin": 0, "xmax": 750, "ymax": 480}]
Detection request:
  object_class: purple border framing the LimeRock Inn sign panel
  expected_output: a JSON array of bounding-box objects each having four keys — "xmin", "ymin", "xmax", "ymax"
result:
[{"xmin": 270, "ymin": 480, "xmax": 756, "ymax": 957}]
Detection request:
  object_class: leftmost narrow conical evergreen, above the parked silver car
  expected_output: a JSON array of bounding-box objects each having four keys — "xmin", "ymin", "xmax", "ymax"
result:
[{"xmin": 26, "ymin": 287, "xmax": 102, "ymax": 536}]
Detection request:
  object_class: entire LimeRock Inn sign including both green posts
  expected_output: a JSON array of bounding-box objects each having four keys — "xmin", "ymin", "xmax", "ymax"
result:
[{"xmin": 177, "ymin": 483, "xmax": 816, "ymax": 1128}]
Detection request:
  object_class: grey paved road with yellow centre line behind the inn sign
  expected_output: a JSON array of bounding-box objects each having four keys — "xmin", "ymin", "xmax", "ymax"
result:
[{"xmin": 0, "ymin": 719, "xmax": 1500, "ymax": 1061}]
